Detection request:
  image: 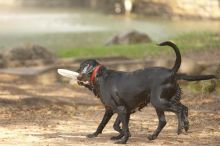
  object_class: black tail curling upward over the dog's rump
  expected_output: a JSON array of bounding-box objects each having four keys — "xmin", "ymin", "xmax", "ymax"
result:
[{"xmin": 158, "ymin": 41, "xmax": 181, "ymax": 74}]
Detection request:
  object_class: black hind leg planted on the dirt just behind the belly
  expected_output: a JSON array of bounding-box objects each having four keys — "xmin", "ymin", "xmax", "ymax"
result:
[{"xmin": 148, "ymin": 109, "xmax": 166, "ymax": 140}]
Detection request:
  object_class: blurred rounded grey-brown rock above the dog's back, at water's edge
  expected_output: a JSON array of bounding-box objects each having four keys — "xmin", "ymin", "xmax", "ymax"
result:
[{"xmin": 106, "ymin": 30, "xmax": 151, "ymax": 45}]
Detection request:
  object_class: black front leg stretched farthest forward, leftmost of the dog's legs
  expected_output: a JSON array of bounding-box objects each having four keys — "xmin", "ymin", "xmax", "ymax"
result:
[{"xmin": 87, "ymin": 109, "xmax": 113, "ymax": 138}]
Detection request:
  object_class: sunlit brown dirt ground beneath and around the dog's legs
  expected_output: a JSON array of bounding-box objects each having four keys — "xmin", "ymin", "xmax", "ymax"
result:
[{"xmin": 0, "ymin": 75, "xmax": 220, "ymax": 146}]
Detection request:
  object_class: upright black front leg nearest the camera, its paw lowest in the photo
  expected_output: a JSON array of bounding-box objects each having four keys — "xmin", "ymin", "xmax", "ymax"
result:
[{"xmin": 116, "ymin": 106, "xmax": 130, "ymax": 144}]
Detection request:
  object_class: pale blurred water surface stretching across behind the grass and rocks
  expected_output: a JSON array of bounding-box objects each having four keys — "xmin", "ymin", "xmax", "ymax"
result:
[{"xmin": 0, "ymin": 8, "xmax": 220, "ymax": 49}]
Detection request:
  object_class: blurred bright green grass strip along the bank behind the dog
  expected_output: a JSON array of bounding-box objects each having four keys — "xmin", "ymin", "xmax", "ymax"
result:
[{"xmin": 56, "ymin": 32, "xmax": 220, "ymax": 58}]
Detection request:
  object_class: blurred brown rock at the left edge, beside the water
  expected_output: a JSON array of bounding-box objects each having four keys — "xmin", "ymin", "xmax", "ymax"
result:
[{"xmin": 1, "ymin": 45, "xmax": 56, "ymax": 67}]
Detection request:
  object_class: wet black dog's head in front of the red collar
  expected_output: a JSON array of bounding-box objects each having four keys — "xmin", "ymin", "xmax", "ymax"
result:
[{"xmin": 77, "ymin": 59, "xmax": 100, "ymax": 83}]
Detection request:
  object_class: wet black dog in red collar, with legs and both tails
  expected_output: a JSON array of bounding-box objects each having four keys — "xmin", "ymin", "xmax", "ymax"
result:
[{"xmin": 78, "ymin": 41, "xmax": 215, "ymax": 144}]
